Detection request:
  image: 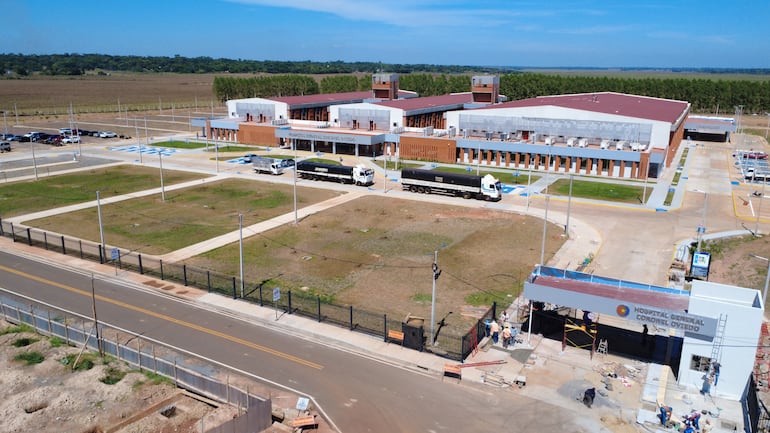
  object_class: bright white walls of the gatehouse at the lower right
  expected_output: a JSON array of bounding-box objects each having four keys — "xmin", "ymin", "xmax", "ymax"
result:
[{"xmin": 678, "ymin": 280, "xmax": 764, "ymax": 400}]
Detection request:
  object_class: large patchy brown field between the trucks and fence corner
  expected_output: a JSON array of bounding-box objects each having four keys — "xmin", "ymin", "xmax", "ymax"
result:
[{"xmin": 186, "ymin": 197, "xmax": 564, "ymax": 332}]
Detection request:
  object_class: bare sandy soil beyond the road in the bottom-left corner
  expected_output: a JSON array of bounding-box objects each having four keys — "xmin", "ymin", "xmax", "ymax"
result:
[{"xmin": 0, "ymin": 321, "xmax": 328, "ymax": 433}]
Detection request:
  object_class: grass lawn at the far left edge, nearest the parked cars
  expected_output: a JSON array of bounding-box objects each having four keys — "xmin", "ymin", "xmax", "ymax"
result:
[{"xmin": 0, "ymin": 165, "xmax": 207, "ymax": 218}]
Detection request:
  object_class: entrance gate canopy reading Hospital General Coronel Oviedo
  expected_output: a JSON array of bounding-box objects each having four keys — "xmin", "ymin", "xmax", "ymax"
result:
[{"xmin": 524, "ymin": 266, "xmax": 717, "ymax": 341}]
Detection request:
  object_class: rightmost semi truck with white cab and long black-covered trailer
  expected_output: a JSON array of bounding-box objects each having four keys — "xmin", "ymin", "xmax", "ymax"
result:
[{"xmin": 401, "ymin": 168, "xmax": 503, "ymax": 201}]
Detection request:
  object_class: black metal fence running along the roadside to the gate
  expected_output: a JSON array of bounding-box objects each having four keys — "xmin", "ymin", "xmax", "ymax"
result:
[{"xmin": 0, "ymin": 220, "xmax": 496, "ymax": 361}]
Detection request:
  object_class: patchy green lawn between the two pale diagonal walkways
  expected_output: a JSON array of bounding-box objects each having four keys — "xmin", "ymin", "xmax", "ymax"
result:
[{"xmin": 26, "ymin": 175, "xmax": 339, "ymax": 254}]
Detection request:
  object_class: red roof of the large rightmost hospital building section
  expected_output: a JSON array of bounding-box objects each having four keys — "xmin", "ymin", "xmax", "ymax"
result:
[{"xmin": 489, "ymin": 92, "xmax": 689, "ymax": 124}]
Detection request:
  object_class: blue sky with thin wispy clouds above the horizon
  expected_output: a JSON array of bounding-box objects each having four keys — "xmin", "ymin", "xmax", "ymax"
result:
[{"xmin": 0, "ymin": 0, "xmax": 770, "ymax": 69}]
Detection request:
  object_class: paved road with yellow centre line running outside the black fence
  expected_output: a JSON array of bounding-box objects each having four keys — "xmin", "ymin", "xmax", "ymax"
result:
[{"xmin": 0, "ymin": 252, "xmax": 612, "ymax": 433}]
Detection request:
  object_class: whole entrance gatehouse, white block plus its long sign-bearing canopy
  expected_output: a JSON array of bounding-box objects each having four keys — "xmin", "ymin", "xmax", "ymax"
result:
[{"xmin": 522, "ymin": 266, "xmax": 764, "ymax": 400}]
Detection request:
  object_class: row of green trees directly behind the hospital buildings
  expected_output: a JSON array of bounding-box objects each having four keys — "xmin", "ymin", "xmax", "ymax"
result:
[{"xmin": 214, "ymin": 73, "xmax": 770, "ymax": 114}]
